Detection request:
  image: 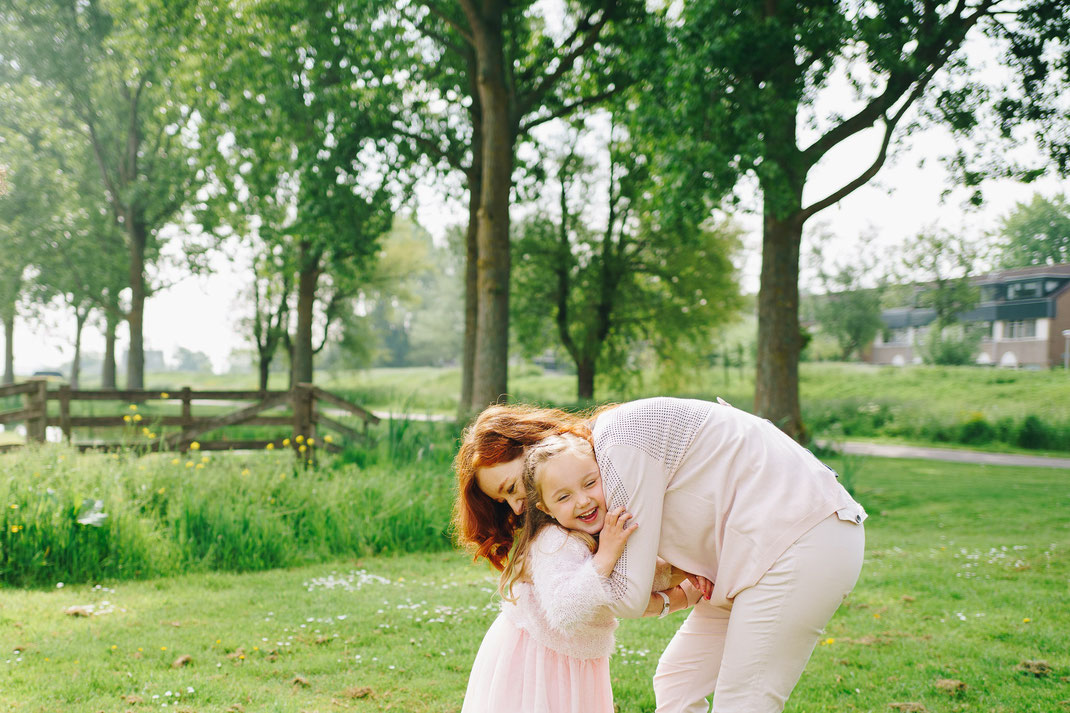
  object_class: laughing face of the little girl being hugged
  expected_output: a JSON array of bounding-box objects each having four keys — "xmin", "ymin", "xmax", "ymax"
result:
[{"xmin": 535, "ymin": 452, "xmax": 606, "ymax": 535}]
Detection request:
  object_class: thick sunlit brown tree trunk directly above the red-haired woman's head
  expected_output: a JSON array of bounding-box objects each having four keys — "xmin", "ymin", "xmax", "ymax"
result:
[{"xmin": 471, "ymin": 5, "xmax": 514, "ymax": 410}]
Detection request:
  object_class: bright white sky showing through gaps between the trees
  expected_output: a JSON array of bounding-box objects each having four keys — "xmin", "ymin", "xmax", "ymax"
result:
[{"xmin": 10, "ymin": 32, "xmax": 1067, "ymax": 376}]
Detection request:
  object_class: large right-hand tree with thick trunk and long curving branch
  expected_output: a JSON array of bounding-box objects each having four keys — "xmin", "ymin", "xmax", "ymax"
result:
[{"xmin": 648, "ymin": 0, "xmax": 1070, "ymax": 440}]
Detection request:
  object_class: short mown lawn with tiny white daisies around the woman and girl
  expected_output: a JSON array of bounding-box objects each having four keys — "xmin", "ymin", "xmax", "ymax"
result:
[{"xmin": 0, "ymin": 458, "xmax": 1070, "ymax": 713}]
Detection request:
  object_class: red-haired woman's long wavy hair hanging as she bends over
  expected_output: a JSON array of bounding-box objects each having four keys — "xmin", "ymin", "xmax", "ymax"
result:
[{"xmin": 453, "ymin": 405, "xmax": 601, "ymax": 571}]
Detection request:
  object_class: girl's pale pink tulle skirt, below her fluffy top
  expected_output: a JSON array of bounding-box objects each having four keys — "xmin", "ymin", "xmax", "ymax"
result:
[{"xmin": 461, "ymin": 613, "xmax": 613, "ymax": 713}]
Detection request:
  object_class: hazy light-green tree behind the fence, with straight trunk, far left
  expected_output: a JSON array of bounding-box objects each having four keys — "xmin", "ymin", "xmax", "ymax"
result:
[{"xmin": 0, "ymin": 0, "xmax": 202, "ymax": 389}]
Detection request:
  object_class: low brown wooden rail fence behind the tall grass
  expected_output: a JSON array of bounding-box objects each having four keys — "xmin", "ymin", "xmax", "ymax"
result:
[{"xmin": 0, "ymin": 379, "xmax": 379, "ymax": 451}]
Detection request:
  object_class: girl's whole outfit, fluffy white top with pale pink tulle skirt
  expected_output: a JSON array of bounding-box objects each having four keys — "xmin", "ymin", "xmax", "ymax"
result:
[{"xmin": 461, "ymin": 526, "xmax": 616, "ymax": 713}]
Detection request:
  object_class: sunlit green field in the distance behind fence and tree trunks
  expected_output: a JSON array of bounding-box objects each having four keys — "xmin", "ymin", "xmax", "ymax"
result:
[{"xmin": 6, "ymin": 363, "xmax": 1070, "ymax": 452}]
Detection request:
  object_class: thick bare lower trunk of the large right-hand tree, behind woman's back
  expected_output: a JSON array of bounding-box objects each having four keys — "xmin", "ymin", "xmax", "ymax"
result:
[{"xmin": 754, "ymin": 212, "xmax": 807, "ymax": 442}]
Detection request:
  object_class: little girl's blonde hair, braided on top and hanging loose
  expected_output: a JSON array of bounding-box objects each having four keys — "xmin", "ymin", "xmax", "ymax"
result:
[{"xmin": 498, "ymin": 433, "xmax": 598, "ymax": 602}]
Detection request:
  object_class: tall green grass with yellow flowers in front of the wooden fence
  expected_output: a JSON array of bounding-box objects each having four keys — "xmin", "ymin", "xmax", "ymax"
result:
[{"xmin": 0, "ymin": 420, "xmax": 456, "ymax": 587}]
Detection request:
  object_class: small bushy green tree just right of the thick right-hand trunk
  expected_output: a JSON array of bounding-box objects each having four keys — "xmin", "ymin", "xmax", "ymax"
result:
[{"xmin": 813, "ymin": 237, "xmax": 885, "ymax": 361}]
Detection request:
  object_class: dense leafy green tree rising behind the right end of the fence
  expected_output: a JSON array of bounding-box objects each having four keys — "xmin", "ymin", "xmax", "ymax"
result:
[{"xmin": 188, "ymin": 0, "xmax": 400, "ymax": 382}]
